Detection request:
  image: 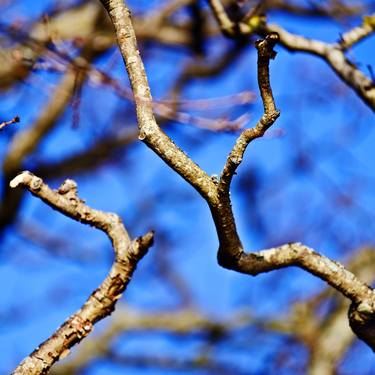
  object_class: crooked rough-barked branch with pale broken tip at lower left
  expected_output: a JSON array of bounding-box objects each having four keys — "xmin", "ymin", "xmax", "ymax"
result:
[{"xmin": 10, "ymin": 172, "xmax": 153, "ymax": 375}]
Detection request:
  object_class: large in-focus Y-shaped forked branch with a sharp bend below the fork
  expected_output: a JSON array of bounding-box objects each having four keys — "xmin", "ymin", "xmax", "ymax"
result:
[{"xmin": 101, "ymin": 0, "xmax": 375, "ymax": 349}]
